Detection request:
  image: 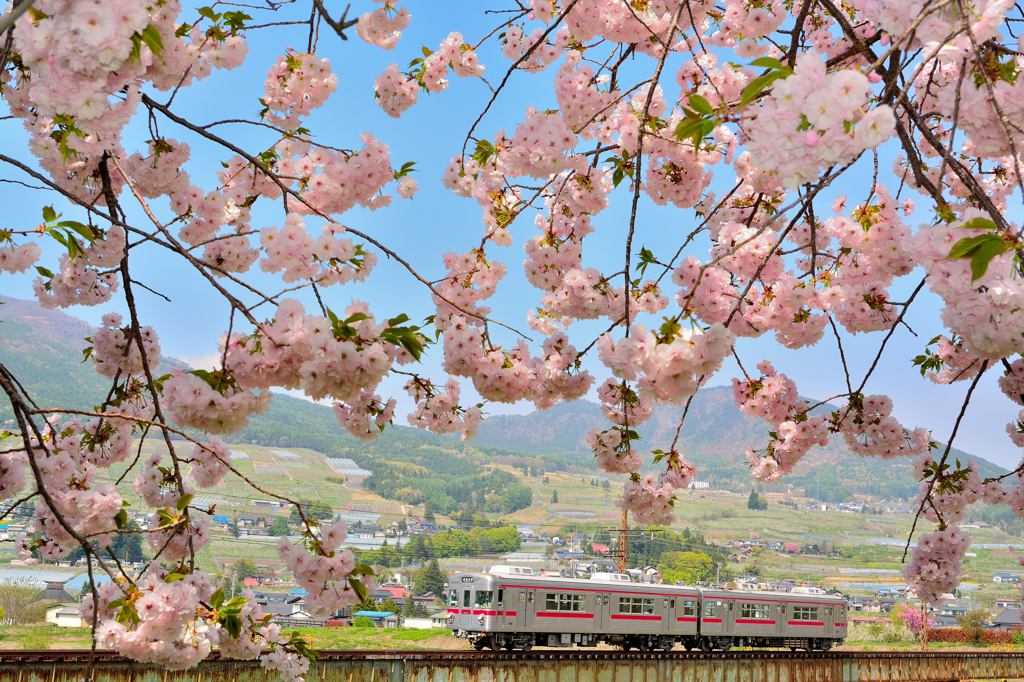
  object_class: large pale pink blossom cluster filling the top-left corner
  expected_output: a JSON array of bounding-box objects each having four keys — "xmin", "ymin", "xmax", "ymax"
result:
[{"xmin": 6, "ymin": 0, "xmax": 248, "ymax": 205}]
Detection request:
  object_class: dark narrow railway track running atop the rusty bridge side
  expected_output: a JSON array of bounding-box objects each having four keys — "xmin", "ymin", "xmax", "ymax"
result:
[{"xmin": 0, "ymin": 649, "xmax": 1024, "ymax": 667}]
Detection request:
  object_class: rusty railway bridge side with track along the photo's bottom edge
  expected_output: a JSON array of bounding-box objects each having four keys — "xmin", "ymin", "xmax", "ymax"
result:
[{"xmin": 0, "ymin": 649, "xmax": 1024, "ymax": 682}]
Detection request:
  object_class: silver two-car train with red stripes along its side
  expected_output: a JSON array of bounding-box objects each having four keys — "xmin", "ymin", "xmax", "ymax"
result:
[{"xmin": 445, "ymin": 566, "xmax": 848, "ymax": 651}]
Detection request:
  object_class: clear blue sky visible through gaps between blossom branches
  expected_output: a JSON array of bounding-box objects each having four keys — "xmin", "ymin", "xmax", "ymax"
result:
[{"xmin": 0, "ymin": 0, "xmax": 1020, "ymax": 473}]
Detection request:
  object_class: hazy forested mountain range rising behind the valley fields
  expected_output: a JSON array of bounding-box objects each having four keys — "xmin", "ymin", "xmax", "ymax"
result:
[{"xmin": 0, "ymin": 296, "xmax": 1005, "ymax": 500}]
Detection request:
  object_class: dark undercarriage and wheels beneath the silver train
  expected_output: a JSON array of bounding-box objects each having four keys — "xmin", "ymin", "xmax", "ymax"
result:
[{"xmin": 456, "ymin": 631, "xmax": 843, "ymax": 652}]
